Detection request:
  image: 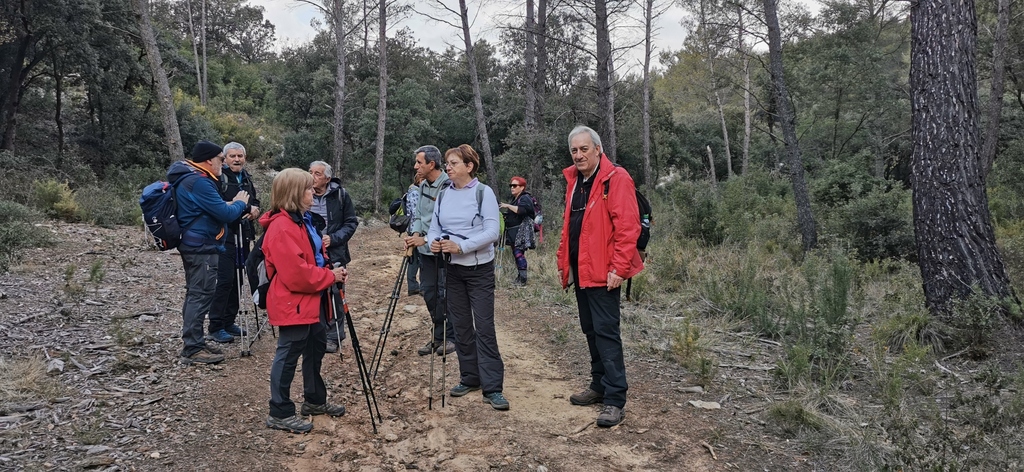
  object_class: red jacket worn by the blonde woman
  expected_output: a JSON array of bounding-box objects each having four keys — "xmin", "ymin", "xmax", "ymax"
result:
[{"xmin": 259, "ymin": 208, "xmax": 334, "ymax": 327}]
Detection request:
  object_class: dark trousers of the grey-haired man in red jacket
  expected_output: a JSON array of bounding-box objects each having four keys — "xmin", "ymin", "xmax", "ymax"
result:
[{"xmin": 575, "ymin": 287, "xmax": 629, "ymax": 407}]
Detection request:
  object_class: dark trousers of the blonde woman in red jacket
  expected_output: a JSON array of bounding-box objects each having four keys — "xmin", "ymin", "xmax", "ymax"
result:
[{"xmin": 270, "ymin": 321, "xmax": 327, "ymax": 418}]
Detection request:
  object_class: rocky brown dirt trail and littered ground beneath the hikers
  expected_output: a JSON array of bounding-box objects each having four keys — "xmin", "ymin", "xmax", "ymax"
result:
[{"xmin": 0, "ymin": 222, "xmax": 810, "ymax": 471}]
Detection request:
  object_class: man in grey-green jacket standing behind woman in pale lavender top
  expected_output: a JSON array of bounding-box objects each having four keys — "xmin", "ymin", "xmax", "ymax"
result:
[{"xmin": 406, "ymin": 145, "xmax": 455, "ymax": 355}]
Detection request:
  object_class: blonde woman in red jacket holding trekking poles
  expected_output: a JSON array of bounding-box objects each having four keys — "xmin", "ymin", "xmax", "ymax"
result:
[{"xmin": 259, "ymin": 169, "xmax": 347, "ymax": 433}]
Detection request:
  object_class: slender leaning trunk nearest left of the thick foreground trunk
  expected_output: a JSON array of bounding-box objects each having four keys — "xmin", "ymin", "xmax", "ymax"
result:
[{"xmin": 764, "ymin": 0, "xmax": 818, "ymax": 252}]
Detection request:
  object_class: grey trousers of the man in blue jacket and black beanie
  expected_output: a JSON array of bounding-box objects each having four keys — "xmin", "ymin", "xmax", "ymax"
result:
[{"xmin": 181, "ymin": 253, "xmax": 220, "ymax": 357}]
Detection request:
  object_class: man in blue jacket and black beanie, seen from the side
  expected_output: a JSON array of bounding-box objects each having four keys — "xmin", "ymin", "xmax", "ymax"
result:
[{"xmin": 167, "ymin": 141, "xmax": 250, "ymax": 364}]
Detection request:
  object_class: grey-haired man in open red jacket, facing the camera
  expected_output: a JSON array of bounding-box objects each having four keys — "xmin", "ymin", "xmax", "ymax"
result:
[{"xmin": 557, "ymin": 126, "xmax": 643, "ymax": 427}]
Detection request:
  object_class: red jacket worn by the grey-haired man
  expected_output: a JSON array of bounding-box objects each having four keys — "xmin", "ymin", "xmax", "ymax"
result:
[{"xmin": 557, "ymin": 154, "xmax": 643, "ymax": 289}]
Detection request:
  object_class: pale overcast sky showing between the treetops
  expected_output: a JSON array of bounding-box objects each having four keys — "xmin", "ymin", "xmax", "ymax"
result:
[{"xmin": 250, "ymin": 0, "xmax": 686, "ymax": 71}]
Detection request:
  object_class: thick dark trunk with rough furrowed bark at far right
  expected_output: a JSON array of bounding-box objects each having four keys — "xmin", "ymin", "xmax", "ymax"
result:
[{"xmin": 910, "ymin": 0, "xmax": 1013, "ymax": 314}]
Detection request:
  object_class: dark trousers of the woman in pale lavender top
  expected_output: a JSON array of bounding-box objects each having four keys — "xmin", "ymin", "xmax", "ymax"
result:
[{"xmin": 447, "ymin": 261, "xmax": 505, "ymax": 395}]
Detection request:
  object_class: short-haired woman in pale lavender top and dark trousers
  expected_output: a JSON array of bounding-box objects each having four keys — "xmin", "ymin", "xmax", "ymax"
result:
[{"xmin": 427, "ymin": 144, "xmax": 509, "ymax": 410}]
